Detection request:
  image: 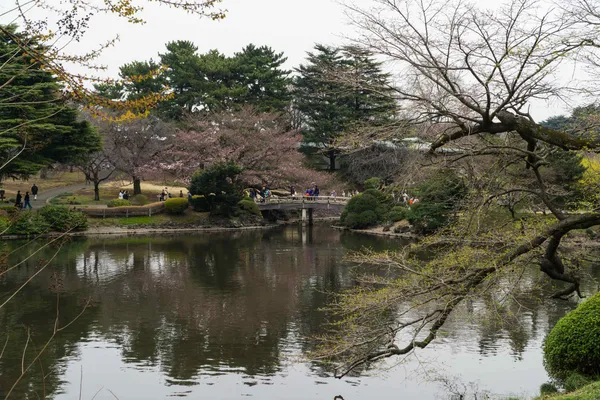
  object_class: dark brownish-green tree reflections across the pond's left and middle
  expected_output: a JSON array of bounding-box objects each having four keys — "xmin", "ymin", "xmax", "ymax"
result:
[{"xmin": 0, "ymin": 227, "xmax": 358, "ymax": 391}]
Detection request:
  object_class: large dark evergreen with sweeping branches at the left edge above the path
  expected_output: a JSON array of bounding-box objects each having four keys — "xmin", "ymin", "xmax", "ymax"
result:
[{"xmin": 0, "ymin": 26, "xmax": 102, "ymax": 180}]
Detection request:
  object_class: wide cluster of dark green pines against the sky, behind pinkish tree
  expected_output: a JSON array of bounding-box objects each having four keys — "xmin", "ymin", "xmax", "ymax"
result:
[{"xmin": 96, "ymin": 40, "xmax": 291, "ymax": 120}]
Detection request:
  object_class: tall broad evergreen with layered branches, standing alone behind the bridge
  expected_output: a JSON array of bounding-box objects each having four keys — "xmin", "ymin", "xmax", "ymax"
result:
[{"xmin": 294, "ymin": 45, "xmax": 396, "ymax": 170}]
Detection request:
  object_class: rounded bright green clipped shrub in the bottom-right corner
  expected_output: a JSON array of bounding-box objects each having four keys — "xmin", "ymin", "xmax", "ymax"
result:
[{"xmin": 544, "ymin": 293, "xmax": 600, "ymax": 381}]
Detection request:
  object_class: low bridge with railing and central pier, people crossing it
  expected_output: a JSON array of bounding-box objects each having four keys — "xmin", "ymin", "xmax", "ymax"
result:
[{"xmin": 257, "ymin": 196, "xmax": 350, "ymax": 224}]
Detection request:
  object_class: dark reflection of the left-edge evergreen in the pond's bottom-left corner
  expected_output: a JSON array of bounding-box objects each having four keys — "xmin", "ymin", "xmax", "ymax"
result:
[{"xmin": 0, "ymin": 248, "xmax": 98, "ymax": 399}]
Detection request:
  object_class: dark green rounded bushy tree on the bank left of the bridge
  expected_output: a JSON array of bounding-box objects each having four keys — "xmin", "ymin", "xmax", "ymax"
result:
[{"xmin": 188, "ymin": 162, "xmax": 243, "ymax": 216}]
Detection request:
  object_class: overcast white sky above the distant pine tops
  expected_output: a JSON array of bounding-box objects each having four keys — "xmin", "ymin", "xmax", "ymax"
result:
[{"xmin": 0, "ymin": 0, "xmax": 580, "ymax": 120}]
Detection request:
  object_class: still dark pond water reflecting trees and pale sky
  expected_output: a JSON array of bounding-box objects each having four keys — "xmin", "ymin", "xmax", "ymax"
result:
[{"xmin": 0, "ymin": 226, "xmax": 598, "ymax": 400}]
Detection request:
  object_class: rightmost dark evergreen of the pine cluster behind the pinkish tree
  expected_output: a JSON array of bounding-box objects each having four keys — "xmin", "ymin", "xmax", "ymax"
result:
[{"xmin": 234, "ymin": 44, "xmax": 291, "ymax": 112}]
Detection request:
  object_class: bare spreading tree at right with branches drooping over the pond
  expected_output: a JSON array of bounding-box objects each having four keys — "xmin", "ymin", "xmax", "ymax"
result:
[{"xmin": 316, "ymin": 0, "xmax": 600, "ymax": 376}]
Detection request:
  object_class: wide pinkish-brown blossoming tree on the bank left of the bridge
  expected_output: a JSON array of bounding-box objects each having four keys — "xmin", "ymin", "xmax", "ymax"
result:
[{"xmin": 156, "ymin": 107, "xmax": 331, "ymax": 187}]
